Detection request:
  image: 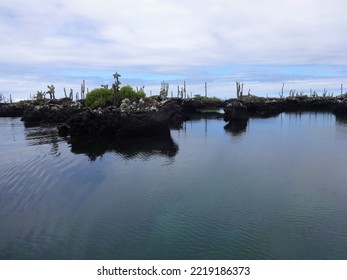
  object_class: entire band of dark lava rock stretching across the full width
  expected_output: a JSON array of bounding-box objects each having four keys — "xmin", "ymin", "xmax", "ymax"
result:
[{"xmin": 0, "ymin": 96, "xmax": 347, "ymax": 137}]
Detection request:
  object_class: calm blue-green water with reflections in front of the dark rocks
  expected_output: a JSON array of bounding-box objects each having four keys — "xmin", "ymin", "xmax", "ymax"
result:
[{"xmin": 0, "ymin": 113, "xmax": 347, "ymax": 259}]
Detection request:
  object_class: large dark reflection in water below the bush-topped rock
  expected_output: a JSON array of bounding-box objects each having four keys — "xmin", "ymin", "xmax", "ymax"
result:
[{"xmin": 70, "ymin": 134, "xmax": 178, "ymax": 161}]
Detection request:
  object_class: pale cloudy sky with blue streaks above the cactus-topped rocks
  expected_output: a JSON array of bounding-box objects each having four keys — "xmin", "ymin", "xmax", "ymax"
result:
[{"xmin": 0, "ymin": 0, "xmax": 347, "ymax": 100}]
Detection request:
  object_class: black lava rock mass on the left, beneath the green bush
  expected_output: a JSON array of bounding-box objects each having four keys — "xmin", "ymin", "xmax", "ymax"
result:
[{"xmin": 0, "ymin": 98, "xmax": 183, "ymax": 137}]
